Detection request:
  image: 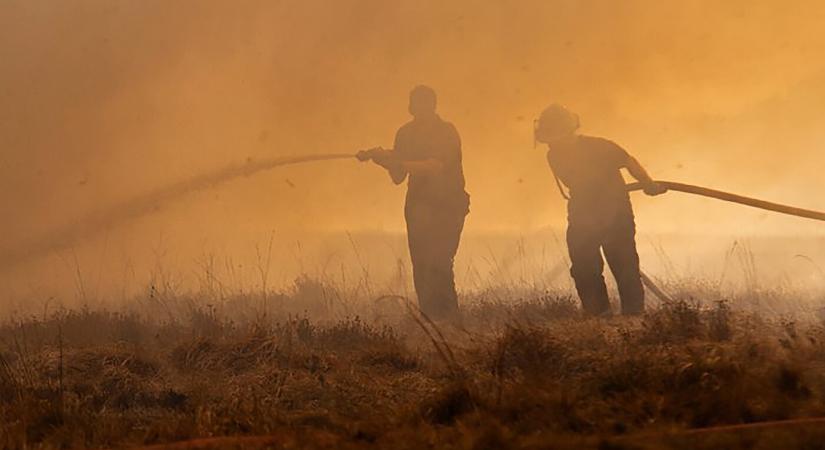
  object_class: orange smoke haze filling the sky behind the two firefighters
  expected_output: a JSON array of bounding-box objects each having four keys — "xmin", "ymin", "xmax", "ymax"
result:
[{"xmin": 0, "ymin": 0, "xmax": 825, "ymax": 306}]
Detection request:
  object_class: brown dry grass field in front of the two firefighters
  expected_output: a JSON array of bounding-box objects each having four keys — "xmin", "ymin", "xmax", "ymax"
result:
[{"xmin": 0, "ymin": 280, "xmax": 825, "ymax": 449}]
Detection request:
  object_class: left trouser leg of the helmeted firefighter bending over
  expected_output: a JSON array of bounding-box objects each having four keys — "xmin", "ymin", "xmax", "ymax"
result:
[{"xmin": 567, "ymin": 224, "xmax": 610, "ymax": 315}]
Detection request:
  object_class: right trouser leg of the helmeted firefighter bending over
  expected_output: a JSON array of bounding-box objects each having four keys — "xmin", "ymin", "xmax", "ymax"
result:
[{"xmin": 603, "ymin": 215, "xmax": 645, "ymax": 314}]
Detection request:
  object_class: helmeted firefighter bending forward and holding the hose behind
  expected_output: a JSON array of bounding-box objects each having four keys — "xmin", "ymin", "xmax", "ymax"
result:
[{"xmin": 535, "ymin": 105, "xmax": 667, "ymax": 315}]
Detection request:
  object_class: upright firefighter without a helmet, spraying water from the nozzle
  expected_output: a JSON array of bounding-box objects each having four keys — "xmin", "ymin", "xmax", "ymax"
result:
[{"xmin": 358, "ymin": 86, "xmax": 470, "ymax": 319}]
